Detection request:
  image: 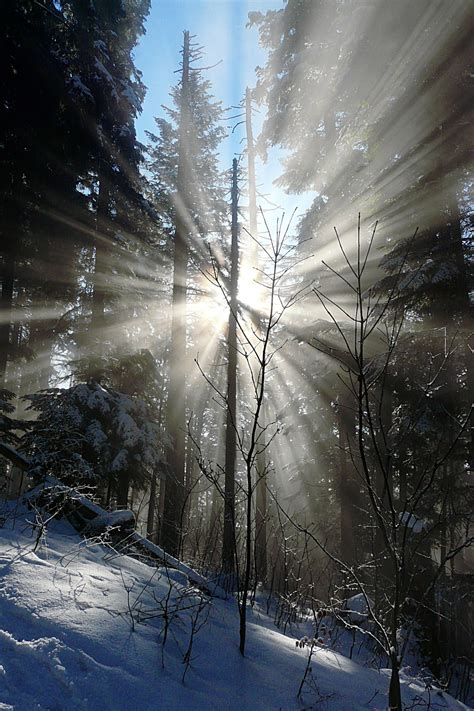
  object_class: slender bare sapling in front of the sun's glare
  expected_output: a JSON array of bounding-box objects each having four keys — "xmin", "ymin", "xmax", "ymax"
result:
[{"xmin": 193, "ymin": 213, "xmax": 307, "ymax": 655}]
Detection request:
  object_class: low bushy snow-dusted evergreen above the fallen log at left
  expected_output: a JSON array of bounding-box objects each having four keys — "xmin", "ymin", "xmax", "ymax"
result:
[{"xmin": 21, "ymin": 382, "xmax": 161, "ymax": 506}]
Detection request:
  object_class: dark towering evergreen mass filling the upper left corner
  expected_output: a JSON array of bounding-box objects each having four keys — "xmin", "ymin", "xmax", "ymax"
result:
[{"xmin": 0, "ymin": 0, "xmax": 149, "ymax": 392}]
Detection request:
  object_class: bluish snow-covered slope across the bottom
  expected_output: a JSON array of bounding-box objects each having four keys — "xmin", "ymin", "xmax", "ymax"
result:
[{"xmin": 0, "ymin": 509, "xmax": 467, "ymax": 711}]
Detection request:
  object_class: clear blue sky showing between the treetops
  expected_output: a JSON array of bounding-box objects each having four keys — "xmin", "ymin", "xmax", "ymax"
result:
[{"xmin": 135, "ymin": 0, "xmax": 308, "ymax": 222}]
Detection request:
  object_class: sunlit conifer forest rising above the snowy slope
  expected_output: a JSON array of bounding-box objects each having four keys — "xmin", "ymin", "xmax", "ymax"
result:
[{"xmin": 0, "ymin": 0, "xmax": 474, "ymax": 711}]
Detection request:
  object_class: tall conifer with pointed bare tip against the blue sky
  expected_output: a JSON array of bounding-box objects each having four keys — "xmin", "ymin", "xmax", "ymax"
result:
[{"xmin": 148, "ymin": 32, "xmax": 229, "ymax": 554}]
